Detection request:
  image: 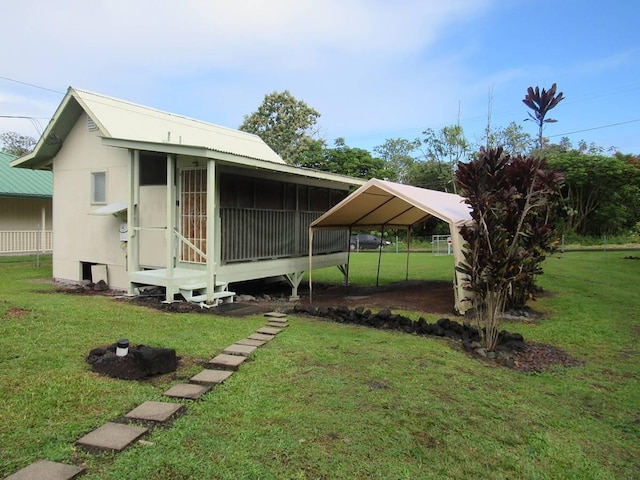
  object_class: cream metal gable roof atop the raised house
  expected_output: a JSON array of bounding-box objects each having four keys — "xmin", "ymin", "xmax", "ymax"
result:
[{"xmin": 13, "ymin": 87, "xmax": 285, "ymax": 169}]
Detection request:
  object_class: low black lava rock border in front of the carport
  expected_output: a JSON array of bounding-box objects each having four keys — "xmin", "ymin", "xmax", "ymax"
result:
[{"xmin": 293, "ymin": 305, "xmax": 527, "ymax": 358}]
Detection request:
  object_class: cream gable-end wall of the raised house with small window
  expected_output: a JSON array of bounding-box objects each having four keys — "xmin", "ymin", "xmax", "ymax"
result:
[{"xmin": 53, "ymin": 113, "xmax": 129, "ymax": 289}]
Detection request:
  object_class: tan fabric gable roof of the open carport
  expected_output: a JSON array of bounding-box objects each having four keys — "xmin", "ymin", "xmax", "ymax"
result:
[{"xmin": 310, "ymin": 178, "xmax": 471, "ymax": 229}]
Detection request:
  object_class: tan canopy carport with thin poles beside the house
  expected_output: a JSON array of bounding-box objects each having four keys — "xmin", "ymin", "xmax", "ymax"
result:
[{"xmin": 309, "ymin": 178, "xmax": 472, "ymax": 314}]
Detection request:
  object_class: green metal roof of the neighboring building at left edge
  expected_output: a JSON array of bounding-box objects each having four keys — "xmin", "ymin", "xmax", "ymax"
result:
[{"xmin": 0, "ymin": 152, "xmax": 53, "ymax": 198}]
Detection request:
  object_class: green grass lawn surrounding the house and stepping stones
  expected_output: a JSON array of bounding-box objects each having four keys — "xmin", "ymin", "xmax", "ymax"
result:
[{"xmin": 0, "ymin": 251, "xmax": 640, "ymax": 479}]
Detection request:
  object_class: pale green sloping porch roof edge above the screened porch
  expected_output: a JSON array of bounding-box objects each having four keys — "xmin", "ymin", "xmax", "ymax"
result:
[{"xmin": 102, "ymin": 137, "xmax": 366, "ymax": 186}]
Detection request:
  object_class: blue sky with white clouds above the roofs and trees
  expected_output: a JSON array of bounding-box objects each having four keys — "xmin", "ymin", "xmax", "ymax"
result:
[{"xmin": 0, "ymin": 0, "xmax": 640, "ymax": 154}]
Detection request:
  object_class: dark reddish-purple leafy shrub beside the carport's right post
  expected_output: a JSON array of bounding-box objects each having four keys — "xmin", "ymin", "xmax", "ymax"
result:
[{"xmin": 456, "ymin": 147, "xmax": 561, "ymax": 350}]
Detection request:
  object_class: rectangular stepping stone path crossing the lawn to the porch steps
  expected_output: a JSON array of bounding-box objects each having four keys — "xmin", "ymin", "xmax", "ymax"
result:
[{"xmin": 6, "ymin": 312, "xmax": 289, "ymax": 480}]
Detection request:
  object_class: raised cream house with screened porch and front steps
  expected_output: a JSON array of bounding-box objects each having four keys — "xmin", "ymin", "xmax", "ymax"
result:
[{"xmin": 13, "ymin": 87, "xmax": 364, "ymax": 305}]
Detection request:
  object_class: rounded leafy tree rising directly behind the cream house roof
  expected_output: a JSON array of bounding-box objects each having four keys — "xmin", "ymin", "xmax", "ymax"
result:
[{"xmin": 239, "ymin": 90, "xmax": 322, "ymax": 165}]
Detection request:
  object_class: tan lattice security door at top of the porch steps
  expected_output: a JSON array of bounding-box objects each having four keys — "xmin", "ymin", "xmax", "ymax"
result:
[{"xmin": 180, "ymin": 169, "xmax": 207, "ymax": 263}]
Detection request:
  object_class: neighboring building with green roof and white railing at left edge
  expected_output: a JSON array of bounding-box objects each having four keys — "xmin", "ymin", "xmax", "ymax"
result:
[{"xmin": 0, "ymin": 152, "xmax": 53, "ymax": 255}]
